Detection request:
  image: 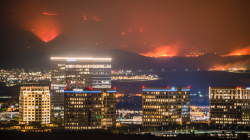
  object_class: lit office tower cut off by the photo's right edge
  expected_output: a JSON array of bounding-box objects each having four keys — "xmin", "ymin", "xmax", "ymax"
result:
[{"xmin": 209, "ymin": 87, "xmax": 250, "ymax": 126}]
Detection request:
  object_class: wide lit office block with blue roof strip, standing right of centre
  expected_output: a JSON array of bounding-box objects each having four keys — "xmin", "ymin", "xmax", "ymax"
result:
[{"xmin": 142, "ymin": 87, "xmax": 190, "ymax": 127}]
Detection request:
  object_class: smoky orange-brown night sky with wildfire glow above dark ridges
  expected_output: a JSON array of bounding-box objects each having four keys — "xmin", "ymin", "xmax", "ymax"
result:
[{"xmin": 0, "ymin": 0, "xmax": 250, "ymax": 55}]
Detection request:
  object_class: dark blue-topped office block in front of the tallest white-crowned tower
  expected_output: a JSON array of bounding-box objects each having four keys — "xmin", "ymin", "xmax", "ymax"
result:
[{"xmin": 64, "ymin": 88, "xmax": 116, "ymax": 130}]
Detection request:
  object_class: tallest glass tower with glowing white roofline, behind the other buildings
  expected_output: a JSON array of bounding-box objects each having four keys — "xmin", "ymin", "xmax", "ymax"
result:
[{"xmin": 51, "ymin": 57, "xmax": 111, "ymax": 117}]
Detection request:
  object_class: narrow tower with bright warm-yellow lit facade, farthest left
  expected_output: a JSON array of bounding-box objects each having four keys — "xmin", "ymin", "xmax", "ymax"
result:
[{"xmin": 19, "ymin": 86, "xmax": 50, "ymax": 124}]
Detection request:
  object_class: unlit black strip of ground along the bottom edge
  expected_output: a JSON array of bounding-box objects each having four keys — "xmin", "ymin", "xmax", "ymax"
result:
[{"xmin": 0, "ymin": 131, "xmax": 247, "ymax": 140}]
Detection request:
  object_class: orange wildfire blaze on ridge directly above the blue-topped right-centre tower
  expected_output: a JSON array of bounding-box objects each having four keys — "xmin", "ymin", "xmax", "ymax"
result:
[{"xmin": 141, "ymin": 46, "xmax": 179, "ymax": 57}]
